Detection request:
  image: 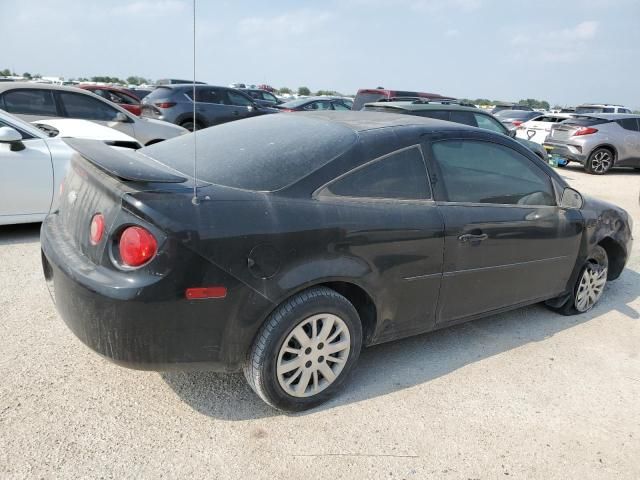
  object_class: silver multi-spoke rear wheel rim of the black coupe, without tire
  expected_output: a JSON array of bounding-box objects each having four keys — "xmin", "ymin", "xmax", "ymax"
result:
[{"xmin": 276, "ymin": 313, "xmax": 351, "ymax": 397}]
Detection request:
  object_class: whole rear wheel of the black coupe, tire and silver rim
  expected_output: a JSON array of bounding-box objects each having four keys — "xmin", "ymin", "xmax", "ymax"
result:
[{"xmin": 243, "ymin": 287, "xmax": 362, "ymax": 412}]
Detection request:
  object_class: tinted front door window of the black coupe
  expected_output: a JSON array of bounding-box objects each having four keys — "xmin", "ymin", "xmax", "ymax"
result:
[{"xmin": 433, "ymin": 140, "xmax": 556, "ymax": 205}]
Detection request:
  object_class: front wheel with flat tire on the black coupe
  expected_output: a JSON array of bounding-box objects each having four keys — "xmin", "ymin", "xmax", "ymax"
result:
[{"xmin": 550, "ymin": 245, "xmax": 609, "ymax": 315}]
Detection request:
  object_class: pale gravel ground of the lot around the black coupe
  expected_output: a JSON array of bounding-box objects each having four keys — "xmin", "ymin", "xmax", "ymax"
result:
[{"xmin": 0, "ymin": 168, "xmax": 640, "ymax": 479}]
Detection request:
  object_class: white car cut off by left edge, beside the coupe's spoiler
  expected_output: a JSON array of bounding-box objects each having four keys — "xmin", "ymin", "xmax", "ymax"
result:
[{"xmin": 0, "ymin": 110, "xmax": 138, "ymax": 225}]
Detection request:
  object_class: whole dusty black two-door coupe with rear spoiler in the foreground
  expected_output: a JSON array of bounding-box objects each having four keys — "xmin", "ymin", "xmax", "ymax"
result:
[{"xmin": 41, "ymin": 112, "xmax": 632, "ymax": 411}]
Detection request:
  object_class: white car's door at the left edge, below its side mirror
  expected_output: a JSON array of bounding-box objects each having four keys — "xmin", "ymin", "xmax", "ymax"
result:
[{"xmin": 0, "ymin": 121, "xmax": 53, "ymax": 224}]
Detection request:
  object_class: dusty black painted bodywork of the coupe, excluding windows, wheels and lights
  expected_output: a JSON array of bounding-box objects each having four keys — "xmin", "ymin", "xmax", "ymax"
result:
[{"xmin": 41, "ymin": 112, "xmax": 631, "ymax": 371}]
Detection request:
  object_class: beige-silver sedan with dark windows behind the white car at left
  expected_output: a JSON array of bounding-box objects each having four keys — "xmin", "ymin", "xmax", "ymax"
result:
[{"xmin": 0, "ymin": 82, "xmax": 189, "ymax": 146}]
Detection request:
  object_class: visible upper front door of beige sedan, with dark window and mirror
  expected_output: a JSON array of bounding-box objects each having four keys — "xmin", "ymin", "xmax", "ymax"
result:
[{"xmin": 55, "ymin": 90, "xmax": 136, "ymax": 137}]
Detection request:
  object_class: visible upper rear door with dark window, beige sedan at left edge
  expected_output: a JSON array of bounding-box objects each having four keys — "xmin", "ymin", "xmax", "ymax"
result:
[{"xmin": 0, "ymin": 88, "xmax": 61, "ymax": 122}]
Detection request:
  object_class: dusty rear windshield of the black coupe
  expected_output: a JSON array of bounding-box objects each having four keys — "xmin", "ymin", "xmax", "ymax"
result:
[{"xmin": 138, "ymin": 114, "xmax": 357, "ymax": 191}]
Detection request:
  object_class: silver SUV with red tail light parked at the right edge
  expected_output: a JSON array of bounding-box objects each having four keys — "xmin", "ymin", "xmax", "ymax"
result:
[{"xmin": 544, "ymin": 113, "xmax": 640, "ymax": 175}]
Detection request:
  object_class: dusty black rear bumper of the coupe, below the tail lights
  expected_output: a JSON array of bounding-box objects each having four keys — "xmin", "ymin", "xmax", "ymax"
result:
[{"xmin": 41, "ymin": 215, "xmax": 273, "ymax": 371}]
